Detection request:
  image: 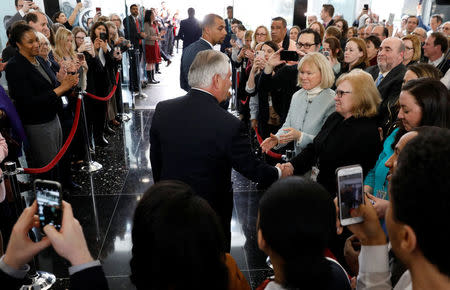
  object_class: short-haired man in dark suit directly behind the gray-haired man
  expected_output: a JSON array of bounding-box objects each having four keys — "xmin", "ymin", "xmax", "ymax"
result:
[{"xmin": 180, "ymin": 14, "xmax": 227, "ymax": 92}]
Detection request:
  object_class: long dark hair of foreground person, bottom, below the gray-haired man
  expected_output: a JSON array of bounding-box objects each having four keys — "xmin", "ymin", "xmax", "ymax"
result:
[{"xmin": 130, "ymin": 181, "xmax": 228, "ymax": 290}]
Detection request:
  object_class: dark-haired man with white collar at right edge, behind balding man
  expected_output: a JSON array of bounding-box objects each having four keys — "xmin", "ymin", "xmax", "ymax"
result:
[{"xmin": 423, "ymin": 32, "xmax": 450, "ymax": 75}]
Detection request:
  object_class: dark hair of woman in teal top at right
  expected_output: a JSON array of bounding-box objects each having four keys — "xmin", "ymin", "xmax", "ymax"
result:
[{"xmin": 392, "ymin": 78, "xmax": 450, "ymax": 149}]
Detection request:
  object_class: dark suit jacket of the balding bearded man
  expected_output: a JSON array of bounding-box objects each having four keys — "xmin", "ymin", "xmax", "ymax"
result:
[{"xmin": 366, "ymin": 64, "xmax": 406, "ymax": 137}]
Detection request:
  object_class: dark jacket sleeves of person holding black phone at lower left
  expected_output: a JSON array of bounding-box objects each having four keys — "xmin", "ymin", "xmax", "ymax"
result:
[{"xmin": 0, "ymin": 266, "xmax": 109, "ymax": 290}]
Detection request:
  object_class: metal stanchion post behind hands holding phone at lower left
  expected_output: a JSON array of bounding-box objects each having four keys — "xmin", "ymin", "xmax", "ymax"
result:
[{"xmin": 4, "ymin": 162, "xmax": 56, "ymax": 290}]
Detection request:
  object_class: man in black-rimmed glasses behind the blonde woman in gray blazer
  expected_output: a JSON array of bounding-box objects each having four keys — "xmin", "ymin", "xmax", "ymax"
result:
[{"xmin": 258, "ymin": 28, "xmax": 320, "ymax": 130}]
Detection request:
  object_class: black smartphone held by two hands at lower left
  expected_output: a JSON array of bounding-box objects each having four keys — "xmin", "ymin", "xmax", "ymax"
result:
[{"xmin": 33, "ymin": 179, "xmax": 62, "ymax": 233}]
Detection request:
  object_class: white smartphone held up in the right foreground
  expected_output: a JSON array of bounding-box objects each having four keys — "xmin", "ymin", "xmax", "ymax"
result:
[{"xmin": 337, "ymin": 165, "xmax": 364, "ymax": 226}]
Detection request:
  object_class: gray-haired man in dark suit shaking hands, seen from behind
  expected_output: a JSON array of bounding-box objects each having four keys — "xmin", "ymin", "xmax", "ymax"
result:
[{"xmin": 150, "ymin": 50, "xmax": 292, "ymax": 246}]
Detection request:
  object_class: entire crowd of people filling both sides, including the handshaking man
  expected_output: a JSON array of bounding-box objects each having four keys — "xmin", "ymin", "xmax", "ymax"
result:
[{"xmin": 0, "ymin": 4, "xmax": 450, "ymax": 290}]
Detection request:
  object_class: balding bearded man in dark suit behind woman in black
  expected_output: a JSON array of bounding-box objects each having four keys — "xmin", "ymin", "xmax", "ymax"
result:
[{"xmin": 366, "ymin": 37, "xmax": 406, "ymax": 137}]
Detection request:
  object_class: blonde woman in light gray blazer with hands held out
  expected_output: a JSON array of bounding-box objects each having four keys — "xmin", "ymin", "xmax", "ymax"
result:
[{"xmin": 261, "ymin": 52, "xmax": 335, "ymax": 155}]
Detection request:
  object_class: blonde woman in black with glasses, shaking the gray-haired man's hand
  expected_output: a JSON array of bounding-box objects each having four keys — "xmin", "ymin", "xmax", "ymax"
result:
[{"xmin": 284, "ymin": 69, "xmax": 381, "ymax": 196}]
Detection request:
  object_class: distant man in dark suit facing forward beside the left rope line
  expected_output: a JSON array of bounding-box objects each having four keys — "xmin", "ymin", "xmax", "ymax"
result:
[{"xmin": 123, "ymin": 4, "xmax": 146, "ymax": 92}]
